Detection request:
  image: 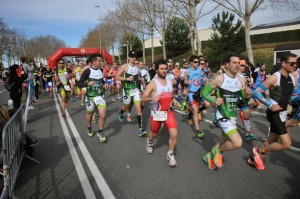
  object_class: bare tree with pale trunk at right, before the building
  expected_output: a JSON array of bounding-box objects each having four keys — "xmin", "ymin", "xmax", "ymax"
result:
[{"xmin": 212, "ymin": 0, "xmax": 296, "ymax": 63}]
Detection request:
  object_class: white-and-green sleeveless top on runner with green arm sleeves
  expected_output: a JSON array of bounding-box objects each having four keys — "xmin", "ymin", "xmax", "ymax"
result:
[{"xmin": 216, "ymin": 73, "xmax": 242, "ymax": 118}]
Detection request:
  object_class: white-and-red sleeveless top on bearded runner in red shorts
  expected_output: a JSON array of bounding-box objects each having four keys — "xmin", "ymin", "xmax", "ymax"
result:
[{"xmin": 152, "ymin": 78, "xmax": 173, "ymax": 111}]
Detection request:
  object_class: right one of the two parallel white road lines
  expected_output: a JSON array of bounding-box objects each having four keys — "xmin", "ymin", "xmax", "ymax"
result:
[{"xmin": 58, "ymin": 96, "xmax": 115, "ymax": 199}]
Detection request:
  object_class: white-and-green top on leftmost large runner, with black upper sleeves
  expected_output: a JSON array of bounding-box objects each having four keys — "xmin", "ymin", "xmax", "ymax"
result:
[{"xmin": 86, "ymin": 68, "xmax": 104, "ymax": 97}]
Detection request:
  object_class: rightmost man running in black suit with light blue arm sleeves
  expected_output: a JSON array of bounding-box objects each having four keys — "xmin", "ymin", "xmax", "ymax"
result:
[{"xmin": 248, "ymin": 53, "xmax": 297, "ymax": 170}]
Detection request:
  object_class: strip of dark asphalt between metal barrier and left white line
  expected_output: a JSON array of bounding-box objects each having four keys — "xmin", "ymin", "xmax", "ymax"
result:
[{"xmin": 15, "ymin": 94, "xmax": 84, "ymax": 199}]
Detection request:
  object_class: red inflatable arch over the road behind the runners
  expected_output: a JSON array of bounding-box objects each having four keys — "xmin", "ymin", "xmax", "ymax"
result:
[{"xmin": 48, "ymin": 48, "xmax": 113, "ymax": 70}]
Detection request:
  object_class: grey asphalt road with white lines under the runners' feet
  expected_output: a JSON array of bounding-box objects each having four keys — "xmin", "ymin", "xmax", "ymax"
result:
[{"xmin": 0, "ymin": 84, "xmax": 300, "ymax": 199}]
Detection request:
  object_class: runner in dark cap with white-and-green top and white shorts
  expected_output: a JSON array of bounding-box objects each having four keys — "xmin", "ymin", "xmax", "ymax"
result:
[{"xmin": 117, "ymin": 51, "xmax": 147, "ymax": 136}]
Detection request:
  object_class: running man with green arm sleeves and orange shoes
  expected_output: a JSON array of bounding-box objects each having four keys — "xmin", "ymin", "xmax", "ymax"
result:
[{"xmin": 201, "ymin": 55, "xmax": 251, "ymax": 169}]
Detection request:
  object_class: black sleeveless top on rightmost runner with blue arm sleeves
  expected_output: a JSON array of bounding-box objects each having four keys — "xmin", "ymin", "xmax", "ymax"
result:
[{"xmin": 269, "ymin": 71, "xmax": 294, "ymax": 111}]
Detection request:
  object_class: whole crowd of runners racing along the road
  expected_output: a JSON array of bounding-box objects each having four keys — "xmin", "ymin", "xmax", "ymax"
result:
[{"xmin": 44, "ymin": 51, "xmax": 300, "ymax": 170}]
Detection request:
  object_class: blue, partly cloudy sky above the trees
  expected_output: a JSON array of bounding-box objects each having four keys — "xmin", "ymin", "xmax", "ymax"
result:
[{"xmin": 0, "ymin": 0, "xmax": 300, "ymax": 47}]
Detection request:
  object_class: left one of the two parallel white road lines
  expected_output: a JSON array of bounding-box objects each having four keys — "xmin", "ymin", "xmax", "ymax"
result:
[{"xmin": 54, "ymin": 93, "xmax": 96, "ymax": 199}]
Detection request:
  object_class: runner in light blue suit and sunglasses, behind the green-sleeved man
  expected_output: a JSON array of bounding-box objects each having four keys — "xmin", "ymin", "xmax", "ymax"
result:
[{"xmin": 185, "ymin": 55, "xmax": 204, "ymax": 138}]
